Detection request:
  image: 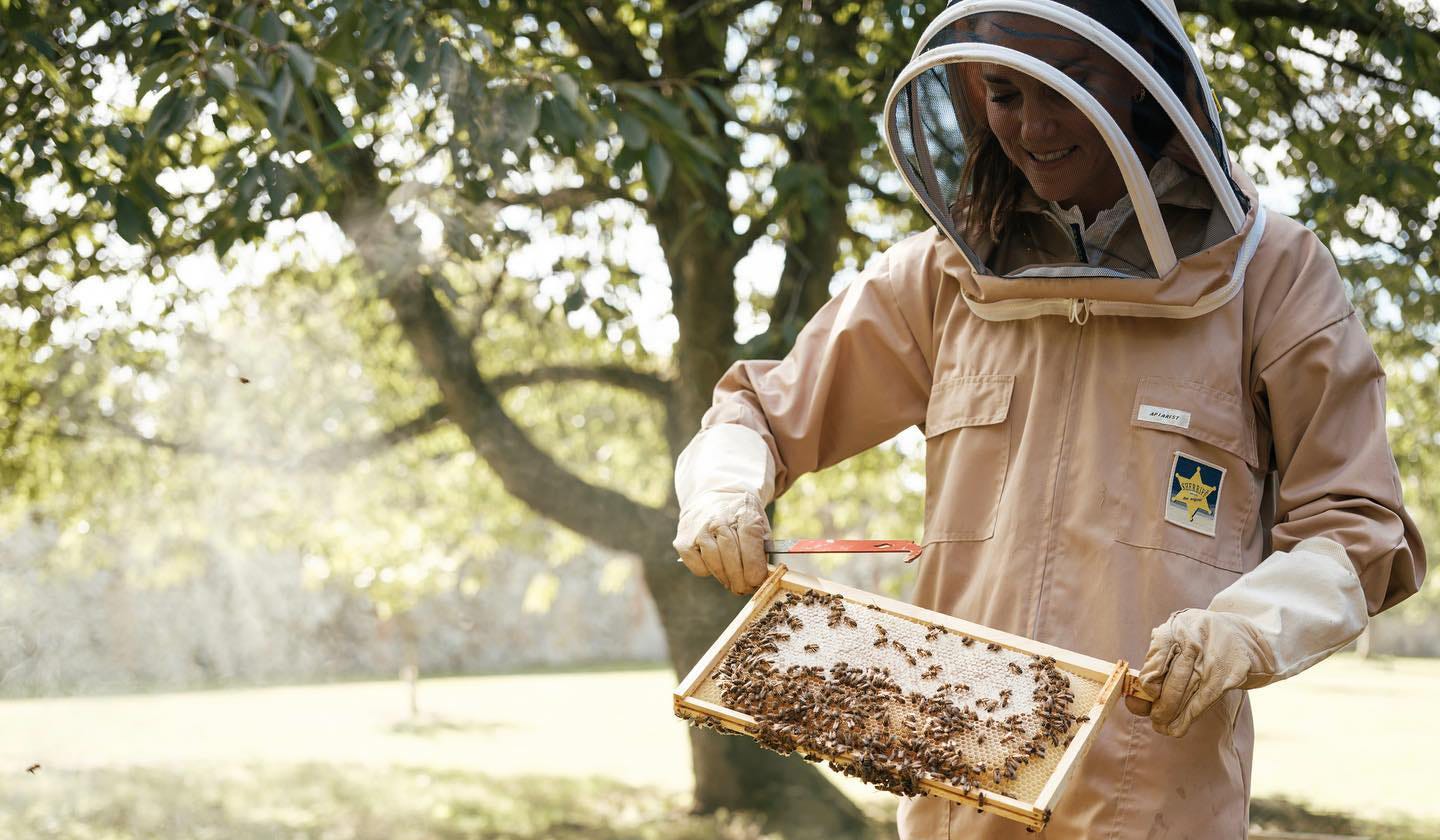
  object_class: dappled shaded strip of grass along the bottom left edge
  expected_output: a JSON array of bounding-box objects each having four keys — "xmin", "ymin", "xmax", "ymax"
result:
[{"xmin": 0, "ymin": 764, "xmax": 794, "ymax": 840}]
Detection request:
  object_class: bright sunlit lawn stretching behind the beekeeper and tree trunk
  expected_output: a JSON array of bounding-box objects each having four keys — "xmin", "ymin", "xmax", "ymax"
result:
[{"xmin": 0, "ymin": 657, "xmax": 1440, "ymax": 840}]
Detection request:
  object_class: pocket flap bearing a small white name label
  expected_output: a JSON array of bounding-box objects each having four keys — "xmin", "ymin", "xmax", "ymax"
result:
[{"xmin": 1130, "ymin": 376, "xmax": 1260, "ymax": 470}]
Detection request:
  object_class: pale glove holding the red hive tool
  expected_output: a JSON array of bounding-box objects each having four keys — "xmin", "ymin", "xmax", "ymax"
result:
[{"xmin": 674, "ymin": 424, "xmax": 775, "ymax": 595}]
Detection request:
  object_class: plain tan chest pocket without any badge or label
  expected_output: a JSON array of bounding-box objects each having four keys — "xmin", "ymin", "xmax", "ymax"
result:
[{"xmin": 924, "ymin": 375, "xmax": 1015, "ymax": 542}]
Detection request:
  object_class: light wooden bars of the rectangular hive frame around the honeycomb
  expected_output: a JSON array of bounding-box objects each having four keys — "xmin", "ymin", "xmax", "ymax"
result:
[{"xmin": 674, "ymin": 565, "xmax": 1140, "ymax": 830}]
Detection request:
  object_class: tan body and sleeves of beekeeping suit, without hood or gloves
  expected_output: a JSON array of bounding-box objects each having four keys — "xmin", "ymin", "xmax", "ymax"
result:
[{"xmin": 704, "ymin": 187, "xmax": 1424, "ymax": 840}]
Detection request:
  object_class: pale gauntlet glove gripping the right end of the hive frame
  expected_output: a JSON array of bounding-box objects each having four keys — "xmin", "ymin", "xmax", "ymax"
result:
[{"xmin": 1126, "ymin": 537, "xmax": 1369, "ymax": 738}]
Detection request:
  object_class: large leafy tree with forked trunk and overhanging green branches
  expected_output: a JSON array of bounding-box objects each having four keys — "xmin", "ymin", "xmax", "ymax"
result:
[{"xmin": 0, "ymin": 0, "xmax": 1440, "ymax": 833}]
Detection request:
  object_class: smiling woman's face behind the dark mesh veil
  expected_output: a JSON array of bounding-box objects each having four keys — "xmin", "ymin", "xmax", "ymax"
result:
[{"xmin": 979, "ymin": 19, "xmax": 1151, "ymax": 220}]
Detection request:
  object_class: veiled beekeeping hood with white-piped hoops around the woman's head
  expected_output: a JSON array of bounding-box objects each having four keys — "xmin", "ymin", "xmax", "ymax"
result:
[{"xmin": 884, "ymin": 0, "xmax": 1264, "ymax": 320}]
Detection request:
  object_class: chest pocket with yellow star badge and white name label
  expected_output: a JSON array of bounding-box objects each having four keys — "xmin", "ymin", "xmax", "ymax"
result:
[{"xmin": 1110, "ymin": 376, "xmax": 1260, "ymax": 572}]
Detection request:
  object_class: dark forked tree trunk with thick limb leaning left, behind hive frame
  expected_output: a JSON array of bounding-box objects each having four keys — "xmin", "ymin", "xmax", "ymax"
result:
[{"xmin": 341, "ymin": 156, "xmax": 868, "ymax": 840}]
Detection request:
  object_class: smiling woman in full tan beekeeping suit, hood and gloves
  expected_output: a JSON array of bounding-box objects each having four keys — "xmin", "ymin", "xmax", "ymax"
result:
[{"xmin": 675, "ymin": 0, "xmax": 1424, "ymax": 840}]
